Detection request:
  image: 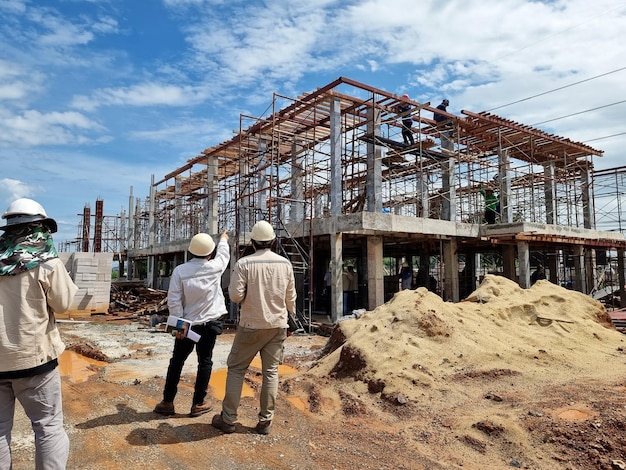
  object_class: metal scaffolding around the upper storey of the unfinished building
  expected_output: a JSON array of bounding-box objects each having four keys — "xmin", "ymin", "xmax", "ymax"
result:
[{"xmin": 70, "ymin": 77, "xmax": 625, "ymax": 320}]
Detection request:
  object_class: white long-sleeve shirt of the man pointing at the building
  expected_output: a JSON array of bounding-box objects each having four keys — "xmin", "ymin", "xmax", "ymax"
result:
[{"xmin": 167, "ymin": 238, "xmax": 230, "ymax": 325}]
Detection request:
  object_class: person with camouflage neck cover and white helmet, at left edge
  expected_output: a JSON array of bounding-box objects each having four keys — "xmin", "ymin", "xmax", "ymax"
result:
[{"xmin": 0, "ymin": 198, "xmax": 78, "ymax": 470}]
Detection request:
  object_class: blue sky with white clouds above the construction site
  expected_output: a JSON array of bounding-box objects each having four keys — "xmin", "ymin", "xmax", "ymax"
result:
[{"xmin": 0, "ymin": 0, "xmax": 626, "ymax": 241}]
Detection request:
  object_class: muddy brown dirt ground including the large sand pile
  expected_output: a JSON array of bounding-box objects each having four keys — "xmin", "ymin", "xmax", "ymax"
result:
[{"xmin": 12, "ymin": 276, "xmax": 626, "ymax": 470}]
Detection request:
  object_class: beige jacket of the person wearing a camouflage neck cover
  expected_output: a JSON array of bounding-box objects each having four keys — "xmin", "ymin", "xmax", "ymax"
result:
[{"xmin": 0, "ymin": 258, "xmax": 78, "ymax": 372}]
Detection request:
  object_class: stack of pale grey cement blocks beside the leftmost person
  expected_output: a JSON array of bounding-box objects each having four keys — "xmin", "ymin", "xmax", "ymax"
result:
[{"xmin": 57, "ymin": 252, "xmax": 113, "ymax": 318}]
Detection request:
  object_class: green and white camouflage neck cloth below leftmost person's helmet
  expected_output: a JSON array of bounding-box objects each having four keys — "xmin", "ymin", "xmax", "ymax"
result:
[{"xmin": 0, "ymin": 224, "xmax": 58, "ymax": 276}]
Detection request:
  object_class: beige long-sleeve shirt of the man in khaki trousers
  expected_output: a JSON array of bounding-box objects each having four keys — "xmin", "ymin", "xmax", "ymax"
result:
[{"xmin": 228, "ymin": 249, "xmax": 296, "ymax": 330}]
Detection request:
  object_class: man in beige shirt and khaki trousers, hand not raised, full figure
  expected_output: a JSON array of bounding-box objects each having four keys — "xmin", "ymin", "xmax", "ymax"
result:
[{"xmin": 211, "ymin": 221, "xmax": 296, "ymax": 434}]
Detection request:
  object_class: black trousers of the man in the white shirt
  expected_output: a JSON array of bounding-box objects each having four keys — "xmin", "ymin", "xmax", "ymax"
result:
[{"xmin": 163, "ymin": 325, "xmax": 217, "ymax": 405}]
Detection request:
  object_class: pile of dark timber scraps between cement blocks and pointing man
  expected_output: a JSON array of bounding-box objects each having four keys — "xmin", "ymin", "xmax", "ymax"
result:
[{"xmin": 108, "ymin": 281, "xmax": 168, "ymax": 318}]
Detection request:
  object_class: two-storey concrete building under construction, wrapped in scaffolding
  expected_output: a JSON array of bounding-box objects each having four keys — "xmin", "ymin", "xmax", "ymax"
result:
[{"xmin": 77, "ymin": 77, "xmax": 626, "ymax": 326}]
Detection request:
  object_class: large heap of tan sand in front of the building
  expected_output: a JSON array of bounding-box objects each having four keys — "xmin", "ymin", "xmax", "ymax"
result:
[{"xmin": 309, "ymin": 275, "xmax": 625, "ymax": 401}]
